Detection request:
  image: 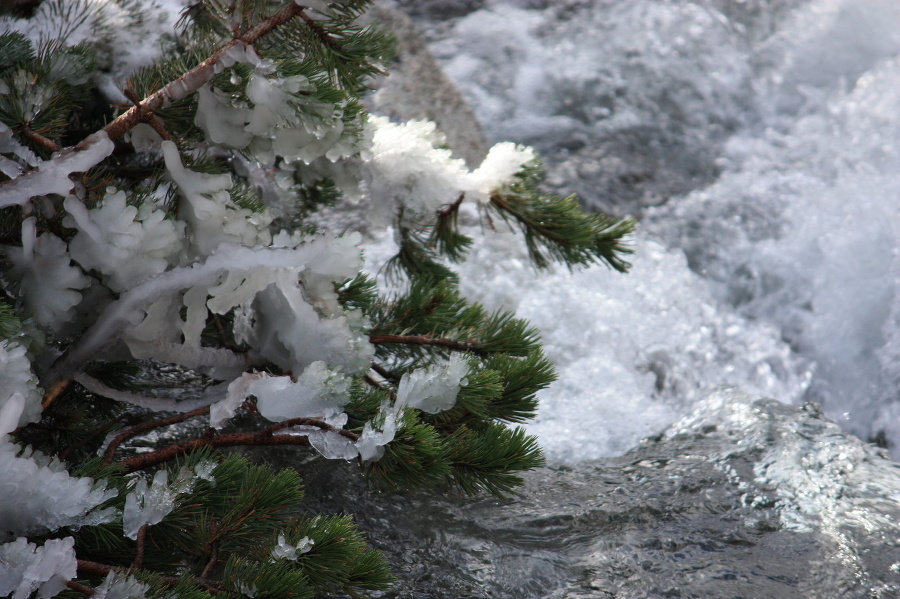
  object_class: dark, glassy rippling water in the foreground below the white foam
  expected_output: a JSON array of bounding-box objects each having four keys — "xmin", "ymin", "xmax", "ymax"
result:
[{"xmin": 305, "ymin": 390, "xmax": 900, "ymax": 599}]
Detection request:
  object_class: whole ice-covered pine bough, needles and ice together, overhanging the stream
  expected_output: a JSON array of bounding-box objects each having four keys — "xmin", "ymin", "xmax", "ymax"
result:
[{"xmin": 0, "ymin": 0, "xmax": 633, "ymax": 599}]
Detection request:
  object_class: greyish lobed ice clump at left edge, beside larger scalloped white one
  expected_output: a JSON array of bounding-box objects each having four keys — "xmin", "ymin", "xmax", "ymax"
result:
[{"xmin": 0, "ymin": 219, "xmax": 90, "ymax": 330}]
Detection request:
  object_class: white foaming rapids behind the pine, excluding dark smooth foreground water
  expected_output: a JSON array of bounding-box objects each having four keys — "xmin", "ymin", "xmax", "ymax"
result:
[{"xmin": 404, "ymin": 0, "xmax": 900, "ymax": 461}]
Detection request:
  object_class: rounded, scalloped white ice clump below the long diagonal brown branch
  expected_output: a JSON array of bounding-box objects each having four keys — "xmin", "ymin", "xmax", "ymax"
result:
[{"xmin": 63, "ymin": 188, "xmax": 183, "ymax": 292}]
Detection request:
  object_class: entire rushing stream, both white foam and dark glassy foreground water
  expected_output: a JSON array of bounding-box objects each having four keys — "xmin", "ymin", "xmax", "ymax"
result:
[{"xmin": 334, "ymin": 0, "xmax": 900, "ymax": 599}]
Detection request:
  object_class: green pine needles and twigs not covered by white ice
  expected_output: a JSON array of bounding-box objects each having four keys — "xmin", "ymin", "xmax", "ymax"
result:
[{"xmin": 0, "ymin": 0, "xmax": 634, "ymax": 599}]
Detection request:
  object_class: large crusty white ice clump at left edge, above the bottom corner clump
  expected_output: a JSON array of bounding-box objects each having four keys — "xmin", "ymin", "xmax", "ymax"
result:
[{"xmin": 0, "ymin": 394, "xmax": 116, "ymax": 535}]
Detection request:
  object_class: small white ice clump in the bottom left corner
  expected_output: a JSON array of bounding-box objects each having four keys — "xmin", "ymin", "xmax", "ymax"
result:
[{"xmin": 0, "ymin": 537, "xmax": 78, "ymax": 599}]
